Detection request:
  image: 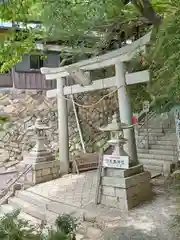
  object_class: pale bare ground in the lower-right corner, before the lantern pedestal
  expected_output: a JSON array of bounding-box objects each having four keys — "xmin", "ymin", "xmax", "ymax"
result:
[{"xmin": 104, "ymin": 187, "xmax": 179, "ymax": 240}]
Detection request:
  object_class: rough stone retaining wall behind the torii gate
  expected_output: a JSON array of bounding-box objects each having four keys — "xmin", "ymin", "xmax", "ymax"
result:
[{"xmin": 0, "ymin": 89, "xmax": 118, "ymax": 167}]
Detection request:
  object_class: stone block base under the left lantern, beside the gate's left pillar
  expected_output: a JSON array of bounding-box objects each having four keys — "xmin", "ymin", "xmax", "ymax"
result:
[{"xmin": 32, "ymin": 161, "xmax": 60, "ymax": 184}]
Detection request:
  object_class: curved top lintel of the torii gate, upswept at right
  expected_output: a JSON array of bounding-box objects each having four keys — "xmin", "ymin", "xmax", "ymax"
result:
[{"xmin": 41, "ymin": 33, "xmax": 151, "ymax": 80}]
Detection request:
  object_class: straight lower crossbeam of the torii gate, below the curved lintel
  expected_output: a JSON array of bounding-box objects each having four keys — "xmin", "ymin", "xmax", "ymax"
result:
[{"xmin": 47, "ymin": 70, "xmax": 150, "ymax": 98}]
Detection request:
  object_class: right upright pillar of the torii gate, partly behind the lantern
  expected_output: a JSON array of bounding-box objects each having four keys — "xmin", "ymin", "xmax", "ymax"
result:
[{"xmin": 115, "ymin": 61, "xmax": 138, "ymax": 163}]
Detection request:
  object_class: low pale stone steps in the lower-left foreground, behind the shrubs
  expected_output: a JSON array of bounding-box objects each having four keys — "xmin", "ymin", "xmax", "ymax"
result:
[{"xmin": 0, "ymin": 190, "xmax": 104, "ymax": 240}]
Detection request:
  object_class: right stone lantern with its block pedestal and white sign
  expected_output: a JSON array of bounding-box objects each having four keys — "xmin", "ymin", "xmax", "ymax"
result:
[{"xmin": 96, "ymin": 114, "xmax": 152, "ymax": 210}]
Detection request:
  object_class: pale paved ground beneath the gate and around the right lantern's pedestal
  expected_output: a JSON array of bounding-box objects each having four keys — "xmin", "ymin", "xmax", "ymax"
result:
[{"xmin": 28, "ymin": 171, "xmax": 179, "ymax": 240}]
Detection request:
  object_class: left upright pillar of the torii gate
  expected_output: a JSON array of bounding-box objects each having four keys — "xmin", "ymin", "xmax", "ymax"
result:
[{"xmin": 57, "ymin": 78, "xmax": 69, "ymax": 174}]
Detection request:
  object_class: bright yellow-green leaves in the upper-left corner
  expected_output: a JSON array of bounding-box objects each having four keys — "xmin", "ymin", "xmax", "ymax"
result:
[{"xmin": 0, "ymin": 0, "xmax": 43, "ymax": 71}]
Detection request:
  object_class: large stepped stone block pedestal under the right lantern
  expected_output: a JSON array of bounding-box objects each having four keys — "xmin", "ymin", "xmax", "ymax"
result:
[{"xmin": 100, "ymin": 164, "xmax": 152, "ymax": 210}]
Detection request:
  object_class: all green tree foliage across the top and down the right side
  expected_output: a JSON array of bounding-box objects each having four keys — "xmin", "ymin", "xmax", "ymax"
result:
[{"xmin": 0, "ymin": 0, "xmax": 180, "ymax": 110}]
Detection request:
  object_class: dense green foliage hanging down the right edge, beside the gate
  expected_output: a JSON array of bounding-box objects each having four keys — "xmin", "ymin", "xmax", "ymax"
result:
[{"xmin": 147, "ymin": 1, "xmax": 180, "ymax": 102}]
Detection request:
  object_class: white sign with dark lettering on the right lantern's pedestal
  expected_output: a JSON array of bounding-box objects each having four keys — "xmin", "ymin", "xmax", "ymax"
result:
[{"xmin": 103, "ymin": 155, "xmax": 129, "ymax": 169}]
